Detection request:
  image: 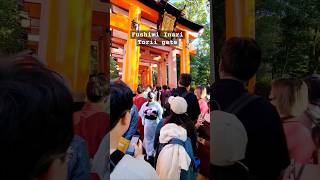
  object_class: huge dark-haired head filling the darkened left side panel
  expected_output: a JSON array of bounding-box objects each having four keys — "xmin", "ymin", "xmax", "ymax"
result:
[{"xmin": 0, "ymin": 55, "xmax": 73, "ymax": 180}]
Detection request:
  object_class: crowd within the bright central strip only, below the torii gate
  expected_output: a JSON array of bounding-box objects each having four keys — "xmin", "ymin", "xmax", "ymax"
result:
[{"xmin": 110, "ymin": 74, "xmax": 210, "ymax": 179}]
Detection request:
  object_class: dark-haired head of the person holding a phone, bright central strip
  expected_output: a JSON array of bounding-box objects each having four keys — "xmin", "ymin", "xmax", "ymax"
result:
[{"xmin": 110, "ymin": 80, "xmax": 133, "ymax": 134}]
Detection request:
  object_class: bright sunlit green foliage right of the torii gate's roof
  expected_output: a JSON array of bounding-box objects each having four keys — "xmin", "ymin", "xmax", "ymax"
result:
[{"xmin": 172, "ymin": 0, "xmax": 210, "ymax": 85}]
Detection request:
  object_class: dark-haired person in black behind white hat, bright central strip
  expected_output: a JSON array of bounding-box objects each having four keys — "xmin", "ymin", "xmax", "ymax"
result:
[{"xmin": 173, "ymin": 74, "xmax": 200, "ymax": 122}]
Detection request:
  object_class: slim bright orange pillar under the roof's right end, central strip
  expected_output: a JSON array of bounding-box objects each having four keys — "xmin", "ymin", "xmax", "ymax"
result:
[{"xmin": 180, "ymin": 31, "xmax": 190, "ymax": 74}]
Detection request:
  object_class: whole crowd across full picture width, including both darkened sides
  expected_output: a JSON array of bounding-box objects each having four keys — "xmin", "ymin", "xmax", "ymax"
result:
[{"xmin": 0, "ymin": 38, "xmax": 320, "ymax": 180}]
